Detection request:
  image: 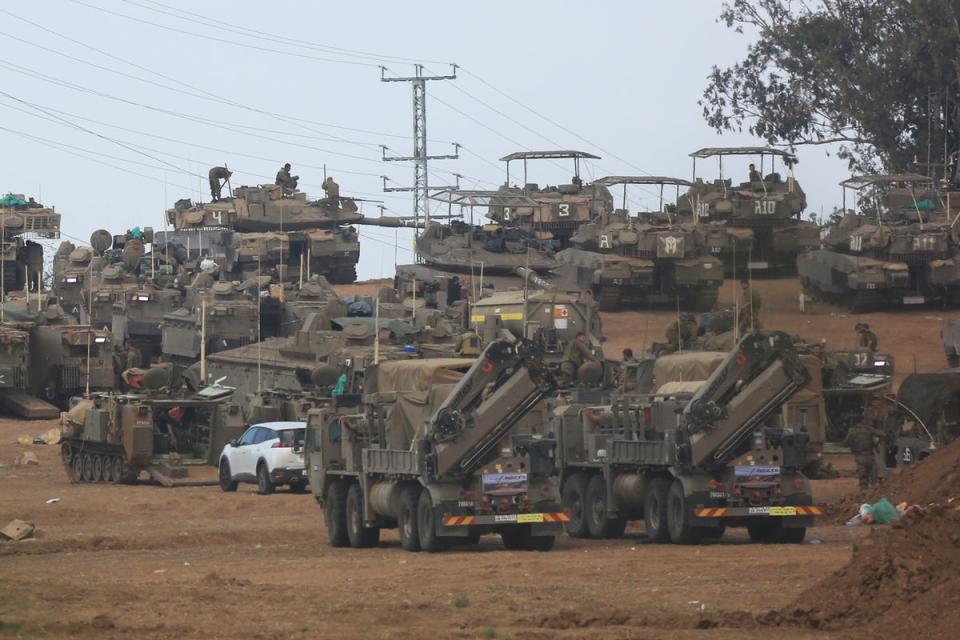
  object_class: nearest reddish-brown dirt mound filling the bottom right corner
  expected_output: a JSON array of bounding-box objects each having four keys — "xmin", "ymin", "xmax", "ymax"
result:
[{"xmin": 758, "ymin": 505, "xmax": 960, "ymax": 640}]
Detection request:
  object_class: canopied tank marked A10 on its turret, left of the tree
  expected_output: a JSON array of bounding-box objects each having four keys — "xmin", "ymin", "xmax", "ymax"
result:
[{"xmin": 677, "ymin": 147, "xmax": 820, "ymax": 277}]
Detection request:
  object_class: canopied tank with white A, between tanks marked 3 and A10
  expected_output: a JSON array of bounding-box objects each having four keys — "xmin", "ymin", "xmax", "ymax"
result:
[{"xmin": 557, "ymin": 176, "xmax": 723, "ymax": 311}]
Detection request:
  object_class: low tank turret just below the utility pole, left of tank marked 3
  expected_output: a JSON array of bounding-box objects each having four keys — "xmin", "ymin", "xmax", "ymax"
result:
[{"xmin": 416, "ymin": 221, "xmax": 557, "ymax": 276}]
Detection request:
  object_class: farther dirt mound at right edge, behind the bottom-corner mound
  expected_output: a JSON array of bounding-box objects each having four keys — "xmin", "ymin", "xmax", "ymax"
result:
[{"xmin": 826, "ymin": 440, "xmax": 960, "ymax": 524}]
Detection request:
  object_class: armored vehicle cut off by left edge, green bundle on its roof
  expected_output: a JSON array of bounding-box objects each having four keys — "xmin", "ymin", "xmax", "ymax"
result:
[{"xmin": 0, "ymin": 193, "xmax": 60, "ymax": 291}]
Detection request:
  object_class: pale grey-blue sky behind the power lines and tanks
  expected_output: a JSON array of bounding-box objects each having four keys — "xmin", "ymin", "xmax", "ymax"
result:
[{"xmin": 0, "ymin": 0, "xmax": 847, "ymax": 279}]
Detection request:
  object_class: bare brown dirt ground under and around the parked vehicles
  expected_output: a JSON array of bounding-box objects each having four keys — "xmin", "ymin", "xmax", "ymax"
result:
[{"xmin": 0, "ymin": 280, "xmax": 948, "ymax": 639}]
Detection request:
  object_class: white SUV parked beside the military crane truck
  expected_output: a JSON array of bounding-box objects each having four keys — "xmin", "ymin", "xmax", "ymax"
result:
[{"xmin": 220, "ymin": 422, "xmax": 307, "ymax": 494}]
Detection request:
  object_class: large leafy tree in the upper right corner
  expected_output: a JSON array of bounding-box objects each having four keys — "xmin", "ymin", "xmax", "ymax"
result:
[{"xmin": 700, "ymin": 0, "xmax": 960, "ymax": 175}]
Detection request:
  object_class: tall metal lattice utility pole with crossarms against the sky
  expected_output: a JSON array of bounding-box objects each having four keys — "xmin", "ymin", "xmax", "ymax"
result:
[{"xmin": 380, "ymin": 64, "xmax": 460, "ymax": 235}]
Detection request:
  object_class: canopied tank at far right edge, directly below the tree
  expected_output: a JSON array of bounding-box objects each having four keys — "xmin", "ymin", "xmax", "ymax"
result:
[{"xmin": 797, "ymin": 174, "xmax": 960, "ymax": 312}]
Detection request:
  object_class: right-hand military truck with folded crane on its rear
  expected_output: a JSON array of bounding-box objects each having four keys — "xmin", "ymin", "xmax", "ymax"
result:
[{"xmin": 552, "ymin": 332, "xmax": 820, "ymax": 544}]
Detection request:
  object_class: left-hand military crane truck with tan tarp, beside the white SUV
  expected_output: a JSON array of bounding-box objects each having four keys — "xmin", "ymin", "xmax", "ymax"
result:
[{"xmin": 305, "ymin": 339, "xmax": 567, "ymax": 551}]
